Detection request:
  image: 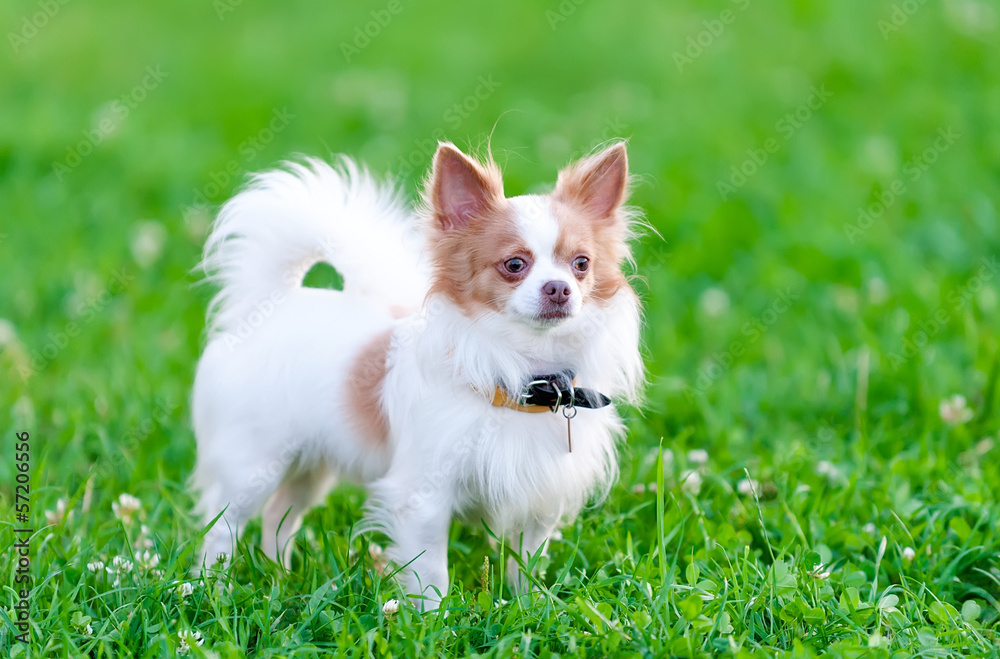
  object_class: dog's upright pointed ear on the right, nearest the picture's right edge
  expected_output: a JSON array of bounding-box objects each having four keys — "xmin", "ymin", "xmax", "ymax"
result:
[{"xmin": 555, "ymin": 142, "xmax": 628, "ymax": 218}]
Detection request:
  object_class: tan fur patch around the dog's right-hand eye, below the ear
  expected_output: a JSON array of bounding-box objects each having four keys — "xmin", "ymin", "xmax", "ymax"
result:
[{"xmin": 550, "ymin": 199, "xmax": 628, "ymax": 303}]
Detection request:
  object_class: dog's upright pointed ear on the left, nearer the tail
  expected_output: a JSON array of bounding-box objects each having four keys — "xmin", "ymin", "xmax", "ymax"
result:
[{"xmin": 431, "ymin": 142, "xmax": 503, "ymax": 231}]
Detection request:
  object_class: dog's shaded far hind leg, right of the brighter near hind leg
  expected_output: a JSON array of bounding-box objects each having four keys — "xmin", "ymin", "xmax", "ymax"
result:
[{"xmin": 260, "ymin": 462, "xmax": 337, "ymax": 570}]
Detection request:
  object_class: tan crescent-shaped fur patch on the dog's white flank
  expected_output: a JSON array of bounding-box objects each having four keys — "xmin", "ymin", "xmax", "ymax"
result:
[{"xmin": 346, "ymin": 330, "xmax": 392, "ymax": 448}]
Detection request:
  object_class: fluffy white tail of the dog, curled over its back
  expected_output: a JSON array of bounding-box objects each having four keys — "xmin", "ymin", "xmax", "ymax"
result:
[{"xmin": 202, "ymin": 158, "xmax": 428, "ymax": 331}]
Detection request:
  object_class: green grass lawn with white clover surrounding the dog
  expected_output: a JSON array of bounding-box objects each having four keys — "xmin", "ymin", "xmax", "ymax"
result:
[{"xmin": 0, "ymin": 0, "xmax": 1000, "ymax": 657}]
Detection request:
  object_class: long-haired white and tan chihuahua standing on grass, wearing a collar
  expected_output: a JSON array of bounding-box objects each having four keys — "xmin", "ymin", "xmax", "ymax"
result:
[{"xmin": 192, "ymin": 143, "xmax": 643, "ymax": 609}]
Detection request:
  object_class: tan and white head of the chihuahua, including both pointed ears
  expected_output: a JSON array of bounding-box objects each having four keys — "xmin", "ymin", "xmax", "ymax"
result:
[{"xmin": 425, "ymin": 143, "xmax": 629, "ymax": 329}]
